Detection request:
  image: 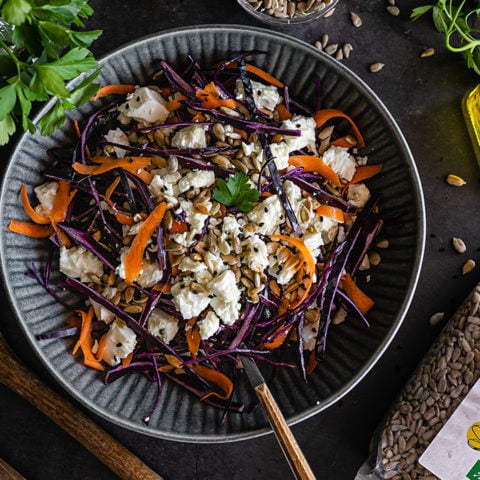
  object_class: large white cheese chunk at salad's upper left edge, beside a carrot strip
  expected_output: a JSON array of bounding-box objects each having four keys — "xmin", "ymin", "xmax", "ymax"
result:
[{"xmin": 118, "ymin": 87, "xmax": 170, "ymax": 124}]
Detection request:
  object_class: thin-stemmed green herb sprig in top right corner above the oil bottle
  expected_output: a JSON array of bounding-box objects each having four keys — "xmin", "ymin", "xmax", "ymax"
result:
[{"xmin": 410, "ymin": 0, "xmax": 480, "ymax": 75}]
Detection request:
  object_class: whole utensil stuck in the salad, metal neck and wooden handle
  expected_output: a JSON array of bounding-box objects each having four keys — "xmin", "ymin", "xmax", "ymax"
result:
[{"xmin": 241, "ymin": 356, "xmax": 315, "ymax": 480}]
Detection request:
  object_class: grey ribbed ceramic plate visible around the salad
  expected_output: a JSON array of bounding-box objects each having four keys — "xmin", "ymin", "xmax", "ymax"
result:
[{"xmin": 0, "ymin": 26, "xmax": 425, "ymax": 442}]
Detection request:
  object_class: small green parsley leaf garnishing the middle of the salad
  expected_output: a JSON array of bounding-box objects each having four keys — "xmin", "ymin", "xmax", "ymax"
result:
[{"xmin": 212, "ymin": 172, "xmax": 260, "ymax": 212}]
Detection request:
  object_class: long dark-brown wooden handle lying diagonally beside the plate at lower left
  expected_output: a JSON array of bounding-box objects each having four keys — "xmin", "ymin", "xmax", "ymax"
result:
[{"xmin": 0, "ymin": 336, "xmax": 163, "ymax": 480}]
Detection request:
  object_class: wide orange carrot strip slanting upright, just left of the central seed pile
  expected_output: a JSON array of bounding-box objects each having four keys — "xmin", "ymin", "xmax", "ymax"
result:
[{"xmin": 125, "ymin": 202, "xmax": 167, "ymax": 285}]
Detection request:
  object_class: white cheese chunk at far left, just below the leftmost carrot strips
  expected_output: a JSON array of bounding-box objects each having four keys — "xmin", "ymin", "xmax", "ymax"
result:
[{"xmin": 60, "ymin": 246, "xmax": 103, "ymax": 282}]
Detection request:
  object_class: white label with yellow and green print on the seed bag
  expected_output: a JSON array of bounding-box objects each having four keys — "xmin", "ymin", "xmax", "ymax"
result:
[{"xmin": 419, "ymin": 380, "xmax": 480, "ymax": 480}]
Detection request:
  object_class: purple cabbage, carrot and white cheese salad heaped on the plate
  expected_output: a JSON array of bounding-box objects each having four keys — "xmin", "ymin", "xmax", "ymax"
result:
[{"xmin": 9, "ymin": 51, "xmax": 382, "ymax": 422}]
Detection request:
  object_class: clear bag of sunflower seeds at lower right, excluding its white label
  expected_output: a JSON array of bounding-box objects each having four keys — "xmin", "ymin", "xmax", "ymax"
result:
[{"xmin": 357, "ymin": 284, "xmax": 480, "ymax": 480}]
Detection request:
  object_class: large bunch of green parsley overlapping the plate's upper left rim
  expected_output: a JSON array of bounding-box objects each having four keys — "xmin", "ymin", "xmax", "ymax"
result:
[{"xmin": 0, "ymin": 0, "xmax": 102, "ymax": 145}]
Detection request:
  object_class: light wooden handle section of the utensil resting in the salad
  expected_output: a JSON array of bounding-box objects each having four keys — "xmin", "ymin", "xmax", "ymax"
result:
[{"xmin": 255, "ymin": 383, "xmax": 315, "ymax": 480}]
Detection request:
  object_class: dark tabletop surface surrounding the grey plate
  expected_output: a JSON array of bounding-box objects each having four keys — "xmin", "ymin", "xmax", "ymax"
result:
[{"xmin": 0, "ymin": 0, "xmax": 480, "ymax": 480}]
